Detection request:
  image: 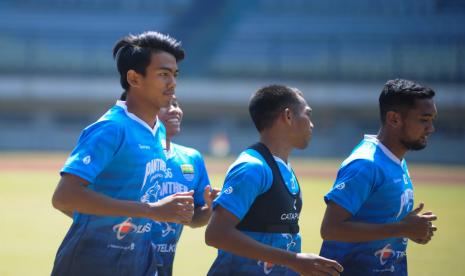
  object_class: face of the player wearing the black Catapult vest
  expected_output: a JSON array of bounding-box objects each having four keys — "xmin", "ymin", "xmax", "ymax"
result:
[{"xmin": 291, "ymin": 96, "xmax": 313, "ymax": 149}]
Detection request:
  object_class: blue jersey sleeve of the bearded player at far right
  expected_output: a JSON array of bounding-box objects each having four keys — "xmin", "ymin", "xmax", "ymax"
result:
[{"xmin": 324, "ymin": 159, "xmax": 376, "ymax": 215}]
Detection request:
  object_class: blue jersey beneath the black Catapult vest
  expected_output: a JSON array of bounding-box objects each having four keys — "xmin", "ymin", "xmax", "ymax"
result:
[{"xmin": 208, "ymin": 149, "xmax": 301, "ymax": 275}]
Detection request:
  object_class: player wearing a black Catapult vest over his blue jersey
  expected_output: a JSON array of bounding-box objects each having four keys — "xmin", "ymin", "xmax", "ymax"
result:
[{"xmin": 205, "ymin": 85, "xmax": 342, "ymax": 275}]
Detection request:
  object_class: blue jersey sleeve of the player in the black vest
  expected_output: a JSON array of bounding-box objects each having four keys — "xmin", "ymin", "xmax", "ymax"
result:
[{"xmin": 213, "ymin": 162, "xmax": 273, "ymax": 220}]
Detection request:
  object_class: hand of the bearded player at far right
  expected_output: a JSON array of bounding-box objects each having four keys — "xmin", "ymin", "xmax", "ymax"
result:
[{"xmin": 401, "ymin": 203, "xmax": 437, "ymax": 244}]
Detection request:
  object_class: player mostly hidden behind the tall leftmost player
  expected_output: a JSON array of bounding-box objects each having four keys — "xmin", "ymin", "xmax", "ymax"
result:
[{"xmin": 152, "ymin": 94, "xmax": 219, "ymax": 276}]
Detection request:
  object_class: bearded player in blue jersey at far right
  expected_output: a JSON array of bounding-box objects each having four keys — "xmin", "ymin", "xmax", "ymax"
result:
[{"xmin": 320, "ymin": 79, "xmax": 437, "ymax": 275}]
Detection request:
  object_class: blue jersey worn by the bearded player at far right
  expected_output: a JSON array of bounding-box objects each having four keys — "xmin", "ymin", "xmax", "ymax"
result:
[{"xmin": 320, "ymin": 135, "xmax": 413, "ymax": 275}]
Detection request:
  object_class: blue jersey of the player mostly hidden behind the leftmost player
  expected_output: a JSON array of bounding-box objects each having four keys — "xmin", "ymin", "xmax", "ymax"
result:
[{"xmin": 152, "ymin": 143, "xmax": 210, "ymax": 276}]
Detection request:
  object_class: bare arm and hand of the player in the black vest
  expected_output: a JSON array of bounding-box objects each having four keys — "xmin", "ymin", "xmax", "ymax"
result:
[{"xmin": 205, "ymin": 205, "xmax": 342, "ymax": 275}]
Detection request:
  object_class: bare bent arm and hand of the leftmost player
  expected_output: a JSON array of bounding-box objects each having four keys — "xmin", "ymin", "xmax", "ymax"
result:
[{"xmin": 52, "ymin": 173, "xmax": 194, "ymax": 223}]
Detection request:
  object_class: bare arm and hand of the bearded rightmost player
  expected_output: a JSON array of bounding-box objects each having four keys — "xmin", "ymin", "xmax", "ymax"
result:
[{"xmin": 320, "ymin": 201, "xmax": 436, "ymax": 243}]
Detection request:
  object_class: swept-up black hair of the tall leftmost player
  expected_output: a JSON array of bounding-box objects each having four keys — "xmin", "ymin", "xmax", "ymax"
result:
[{"xmin": 113, "ymin": 32, "xmax": 185, "ymax": 90}]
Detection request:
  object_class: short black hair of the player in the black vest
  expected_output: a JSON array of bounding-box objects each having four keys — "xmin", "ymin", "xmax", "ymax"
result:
[{"xmin": 249, "ymin": 84, "xmax": 303, "ymax": 132}]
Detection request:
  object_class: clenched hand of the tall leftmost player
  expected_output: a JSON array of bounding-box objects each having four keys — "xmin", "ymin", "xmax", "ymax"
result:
[{"xmin": 149, "ymin": 191, "xmax": 194, "ymax": 224}]
